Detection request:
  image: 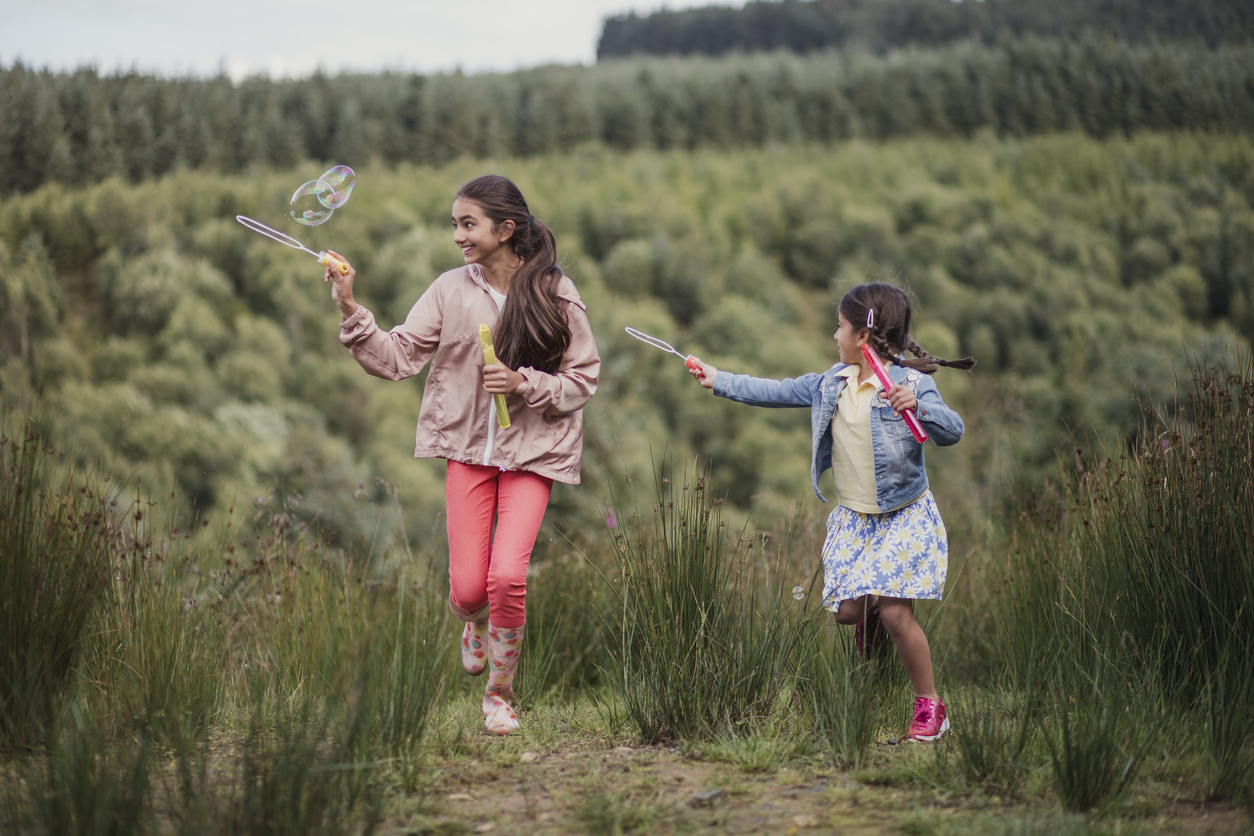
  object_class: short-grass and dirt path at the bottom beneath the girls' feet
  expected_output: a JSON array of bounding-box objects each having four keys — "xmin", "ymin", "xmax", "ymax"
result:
[{"xmin": 379, "ymin": 712, "xmax": 1248, "ymax": 836}]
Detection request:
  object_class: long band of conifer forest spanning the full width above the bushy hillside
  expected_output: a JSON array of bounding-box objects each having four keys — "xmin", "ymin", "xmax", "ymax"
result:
[{"xmin": 7, "ymin": 37, "xmax": 1254, "ymax": 196}]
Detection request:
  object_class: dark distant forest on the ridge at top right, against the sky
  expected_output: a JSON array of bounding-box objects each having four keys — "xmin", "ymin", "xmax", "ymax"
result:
[{"xmin": 597, "ymin": 0, "xmax": 1254, "ymax": 59}]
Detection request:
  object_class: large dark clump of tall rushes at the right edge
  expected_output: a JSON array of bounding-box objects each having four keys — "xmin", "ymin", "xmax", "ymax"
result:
[{"xmin": 968, "ymin": 358, "xmax": 1254, "ymax": 707}]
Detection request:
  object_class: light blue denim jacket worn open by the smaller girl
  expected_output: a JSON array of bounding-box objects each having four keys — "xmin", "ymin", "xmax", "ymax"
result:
[{"xmin": 714, "ymin": 363, "xmax": 963, "ymax": 514}]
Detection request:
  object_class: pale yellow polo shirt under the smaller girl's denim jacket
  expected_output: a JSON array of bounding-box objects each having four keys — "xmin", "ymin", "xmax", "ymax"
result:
[{"xmin": 831, "ymin": 366, "xmax": 884, "ymax": 514}]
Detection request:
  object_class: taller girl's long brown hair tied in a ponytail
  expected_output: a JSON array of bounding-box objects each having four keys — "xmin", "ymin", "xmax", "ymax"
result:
[{"xmin": 458, "ymin": 174, "xmax": 571, "ymax": 375}]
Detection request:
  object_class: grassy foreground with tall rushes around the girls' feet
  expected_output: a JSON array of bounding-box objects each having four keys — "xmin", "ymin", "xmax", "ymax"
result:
[{"xmin": 0, "ymin": 355, "xmax": 1254, "ymax": 833}]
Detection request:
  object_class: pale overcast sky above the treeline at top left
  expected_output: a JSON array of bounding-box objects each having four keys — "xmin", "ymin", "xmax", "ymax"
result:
[{"xmin": 0, "ymin": 0, "xmax": 744, "ymax": 79}]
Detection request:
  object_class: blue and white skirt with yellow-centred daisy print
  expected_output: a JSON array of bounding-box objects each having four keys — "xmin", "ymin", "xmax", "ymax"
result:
[{"xmin": 823, "ymin": 491, "xmax": 949, "ymax": 612}]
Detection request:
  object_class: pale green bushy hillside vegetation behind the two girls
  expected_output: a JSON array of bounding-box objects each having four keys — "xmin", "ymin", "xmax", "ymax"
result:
[{"xmin": 0, "ymin": 134, "xmax": 1254, "ymax": 545}]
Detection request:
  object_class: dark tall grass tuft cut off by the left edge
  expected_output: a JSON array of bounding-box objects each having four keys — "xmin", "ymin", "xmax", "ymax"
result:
[{"xmin": 0, "ymin": 411, "xmax": 114, "ymax": 747}]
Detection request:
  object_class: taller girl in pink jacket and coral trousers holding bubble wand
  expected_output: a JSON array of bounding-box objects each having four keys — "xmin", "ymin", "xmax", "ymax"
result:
[{"xmin": 326, "ymin": 175, "xmax": 601, "ymax": 734}]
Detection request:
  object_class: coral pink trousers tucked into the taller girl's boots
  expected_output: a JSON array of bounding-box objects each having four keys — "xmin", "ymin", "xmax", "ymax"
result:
[{"xmin": 444, "ymin": 461, "xmax": 553, "ymax": 627}]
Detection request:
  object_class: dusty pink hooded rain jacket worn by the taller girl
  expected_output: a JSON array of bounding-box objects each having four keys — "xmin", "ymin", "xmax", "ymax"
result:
[{"xmin": 340, "ymin": 264, "xmax": 601, "ymax": 485}]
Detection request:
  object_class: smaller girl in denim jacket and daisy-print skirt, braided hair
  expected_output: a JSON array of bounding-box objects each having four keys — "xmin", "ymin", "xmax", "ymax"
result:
[{"xmin": 692, "ymin": 282, "xmax": 976, "ymax": 741}]
